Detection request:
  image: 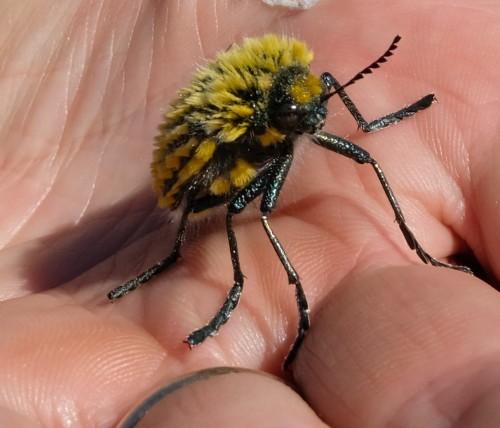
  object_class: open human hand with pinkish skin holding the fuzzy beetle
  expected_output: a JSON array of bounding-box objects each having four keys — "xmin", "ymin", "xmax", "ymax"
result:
[{"xmin": 0, "ymin": 0, "xmax": 500, "ymax": 427}]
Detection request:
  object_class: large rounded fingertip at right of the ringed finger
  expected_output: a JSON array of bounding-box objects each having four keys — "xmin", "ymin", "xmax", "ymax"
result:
[{"xmin": 294, "ymin": 267, "xmax": 500, "ymax": 428}]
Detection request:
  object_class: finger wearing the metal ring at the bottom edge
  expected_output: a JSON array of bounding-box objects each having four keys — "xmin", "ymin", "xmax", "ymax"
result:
[{"xmin": 119, "ymin": 368, "xmax": 326, "ymax": 428}]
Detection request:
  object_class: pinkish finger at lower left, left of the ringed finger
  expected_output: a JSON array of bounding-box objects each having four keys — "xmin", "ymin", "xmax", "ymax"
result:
[{"xmin": 0, "ymin": 294, "xmax": 166, "ymax": 427}]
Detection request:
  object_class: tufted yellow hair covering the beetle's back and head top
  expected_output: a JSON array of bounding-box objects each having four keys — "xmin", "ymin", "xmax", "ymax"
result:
[{"xmin": 151, "ymin": 34, "xmax": 324, "ymax": 209}]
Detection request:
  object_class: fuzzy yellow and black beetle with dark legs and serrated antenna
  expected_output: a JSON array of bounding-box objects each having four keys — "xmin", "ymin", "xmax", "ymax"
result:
[{"xmin": 108, "ymin": 35, "xmax": 471, "ymax": 367}]
